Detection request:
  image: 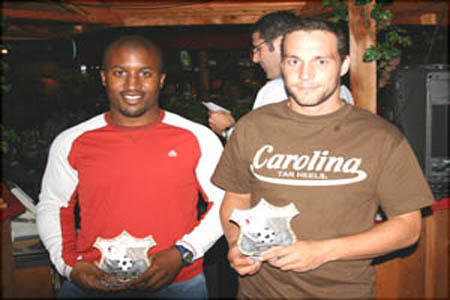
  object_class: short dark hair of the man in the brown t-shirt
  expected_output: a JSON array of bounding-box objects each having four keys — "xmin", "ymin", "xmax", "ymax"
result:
[{"xmin": 281, "ymin": 18, "xmax": 348, "ymax": 60}]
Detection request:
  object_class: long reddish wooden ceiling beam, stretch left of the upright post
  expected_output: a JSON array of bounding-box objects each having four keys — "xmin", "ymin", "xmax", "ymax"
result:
[{"xmin": 2, "ymin": 1, "xmax": 320, "ymax": 26}]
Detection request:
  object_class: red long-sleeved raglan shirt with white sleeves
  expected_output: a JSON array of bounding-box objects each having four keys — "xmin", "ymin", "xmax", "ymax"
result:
[{"xmin": 37, "ymin": 110, "xmax": 224, "ymax": 282}]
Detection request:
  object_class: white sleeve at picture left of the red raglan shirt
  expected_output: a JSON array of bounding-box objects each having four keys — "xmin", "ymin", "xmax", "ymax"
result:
[{"xmin": 36, "ymin": 114, "xmax": 106, "ymax": 279}]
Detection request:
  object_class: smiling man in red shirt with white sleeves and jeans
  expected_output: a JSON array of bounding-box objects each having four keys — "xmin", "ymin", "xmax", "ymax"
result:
[{"xmin": 37, "ymin": 36, "xmax": 224, "ymax": 298}]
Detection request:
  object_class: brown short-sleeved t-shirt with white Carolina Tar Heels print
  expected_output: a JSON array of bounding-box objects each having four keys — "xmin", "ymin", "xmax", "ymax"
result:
[{"xmin": 212, "ymin": 101, "xmax": 433, "ymax": 299}]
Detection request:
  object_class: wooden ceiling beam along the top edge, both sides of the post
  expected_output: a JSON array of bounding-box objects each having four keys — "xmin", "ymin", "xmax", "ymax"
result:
[{"xmin": 2, "ymin": 0, "xmax": 449, "ymax": 39}]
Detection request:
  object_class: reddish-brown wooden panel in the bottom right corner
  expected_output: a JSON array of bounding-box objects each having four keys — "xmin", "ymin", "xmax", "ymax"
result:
[{"xmin": 375, "ymin": 205, "xmax": 450, "ymax": 299}]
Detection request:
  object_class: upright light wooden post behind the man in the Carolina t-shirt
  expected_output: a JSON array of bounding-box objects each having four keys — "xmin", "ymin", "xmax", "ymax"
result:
[{"xmin": 348, "ymin": 0, "xmax": 377, "ymax": 113}]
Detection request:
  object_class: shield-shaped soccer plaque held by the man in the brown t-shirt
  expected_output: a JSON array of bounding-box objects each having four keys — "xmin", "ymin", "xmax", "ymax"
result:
[{"xmin": 230, "ymin": 198, "xmax": 299, "ymax": 259}]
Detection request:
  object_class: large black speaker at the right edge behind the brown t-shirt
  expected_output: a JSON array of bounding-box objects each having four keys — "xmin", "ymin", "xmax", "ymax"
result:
[{"xmin": 388, "ymin": 65, "xmax": 450, "ymax": 199}]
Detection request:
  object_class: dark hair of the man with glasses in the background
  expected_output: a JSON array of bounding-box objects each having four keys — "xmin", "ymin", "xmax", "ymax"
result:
[{"xmin": 251, "ymin": 10, "xmax": 298, "ymax": 50}]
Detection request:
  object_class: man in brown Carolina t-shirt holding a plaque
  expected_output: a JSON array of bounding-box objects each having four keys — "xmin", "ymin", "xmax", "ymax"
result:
[{"xmin": 213, "ymin": 20, "xmax": 433, "ymax": 299}]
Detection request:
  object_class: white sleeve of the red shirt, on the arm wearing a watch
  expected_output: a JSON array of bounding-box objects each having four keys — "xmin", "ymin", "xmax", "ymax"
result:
[{"xmin": 177, "ymin": 127, "xmax": 225, "ymax": 259}]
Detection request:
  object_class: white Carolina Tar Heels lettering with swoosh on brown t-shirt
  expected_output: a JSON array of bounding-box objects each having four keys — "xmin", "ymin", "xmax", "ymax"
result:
[{"xmin": 250, "ymin": 145, "xmax": 367, "ymax": 186}]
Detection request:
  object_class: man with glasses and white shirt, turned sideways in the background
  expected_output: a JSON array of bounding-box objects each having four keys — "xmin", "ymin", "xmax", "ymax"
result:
[{"xmin": 209, "ymin": 11, "xmax": 354, "ymax": 139}]
